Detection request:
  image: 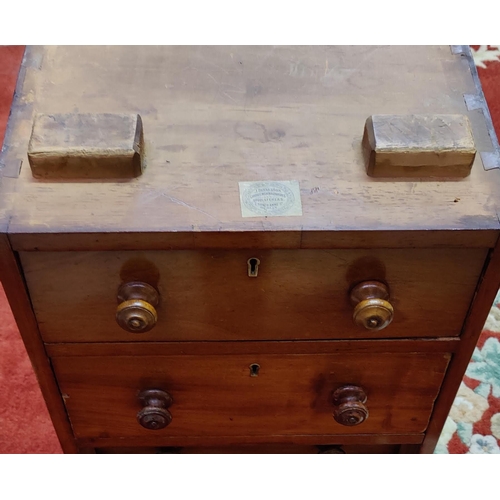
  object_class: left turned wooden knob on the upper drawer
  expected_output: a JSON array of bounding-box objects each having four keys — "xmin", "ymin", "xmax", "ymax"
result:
[{"xmin": 116, "ymin": 281, "xmax": 160, "ymax": 333}]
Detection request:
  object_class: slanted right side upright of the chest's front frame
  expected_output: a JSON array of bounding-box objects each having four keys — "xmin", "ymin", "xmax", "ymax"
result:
[{"xmin": 420, "ymin": 234, "xmax": 500, "ymax": 453}]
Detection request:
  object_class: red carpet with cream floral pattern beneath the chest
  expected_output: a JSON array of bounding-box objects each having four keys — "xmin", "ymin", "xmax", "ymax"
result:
[{"xmin": 0, "ymin": 45, "xmax": 500, "ymax": 454}]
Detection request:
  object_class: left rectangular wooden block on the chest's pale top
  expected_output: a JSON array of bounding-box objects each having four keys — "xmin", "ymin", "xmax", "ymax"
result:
[{"xmin": 28, "ymin": 114, "xmax": 144, "ymax": 179}]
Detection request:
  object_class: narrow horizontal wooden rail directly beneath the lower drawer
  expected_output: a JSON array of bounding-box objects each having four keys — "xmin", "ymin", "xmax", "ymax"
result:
[{"xmin": 76, "ymin": 432, "xmax": 424, "ymax": 449}]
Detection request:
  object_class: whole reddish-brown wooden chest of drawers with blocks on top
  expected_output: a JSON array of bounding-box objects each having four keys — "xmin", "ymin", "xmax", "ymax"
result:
[{"xmin": 0, "ymin": 47, "xmax": 500, "ymax": 453}]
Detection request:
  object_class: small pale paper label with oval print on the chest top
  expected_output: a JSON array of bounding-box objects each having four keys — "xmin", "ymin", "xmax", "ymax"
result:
[{"xmin": 239, "ymin": 181, "xmax": 302, "ymax": 217}]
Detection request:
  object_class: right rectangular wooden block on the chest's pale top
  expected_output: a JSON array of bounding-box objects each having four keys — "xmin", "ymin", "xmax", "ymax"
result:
[{"xmin": 363, "ymin": 115, "xmax": 476, "ymax": 178}]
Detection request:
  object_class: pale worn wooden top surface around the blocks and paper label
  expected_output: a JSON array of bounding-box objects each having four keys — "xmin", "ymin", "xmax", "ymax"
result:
[{"xmin": 0, "ymin": 46, "xmax": 500, "ymax": 246}]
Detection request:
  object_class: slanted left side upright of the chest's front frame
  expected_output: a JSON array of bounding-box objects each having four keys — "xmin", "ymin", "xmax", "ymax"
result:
[{"xmin": 0, "ymin": 234, "xmax": 77, "ymax": 453}]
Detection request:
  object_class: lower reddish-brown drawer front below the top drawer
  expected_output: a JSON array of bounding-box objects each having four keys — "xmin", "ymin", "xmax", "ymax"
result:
[{"xmin": 52, "ymin": 353, "xmax": 450, "ymax": 438}]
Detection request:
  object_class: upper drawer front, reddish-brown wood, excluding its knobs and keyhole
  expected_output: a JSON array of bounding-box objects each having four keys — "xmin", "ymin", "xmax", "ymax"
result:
[{"xmin": 21, "ymin": 249, "xmax": 487, "ymax": 342}]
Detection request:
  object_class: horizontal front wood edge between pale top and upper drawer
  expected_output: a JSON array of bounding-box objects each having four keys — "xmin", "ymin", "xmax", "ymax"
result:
[{"xmin": 9, "ymin": 228, "xmax": 500, "ymax": 251}]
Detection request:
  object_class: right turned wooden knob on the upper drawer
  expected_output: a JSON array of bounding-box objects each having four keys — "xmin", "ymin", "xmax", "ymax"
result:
[{"xmin": 351, "ymin": 281, "xmax": 394, "ymax": 330}]
